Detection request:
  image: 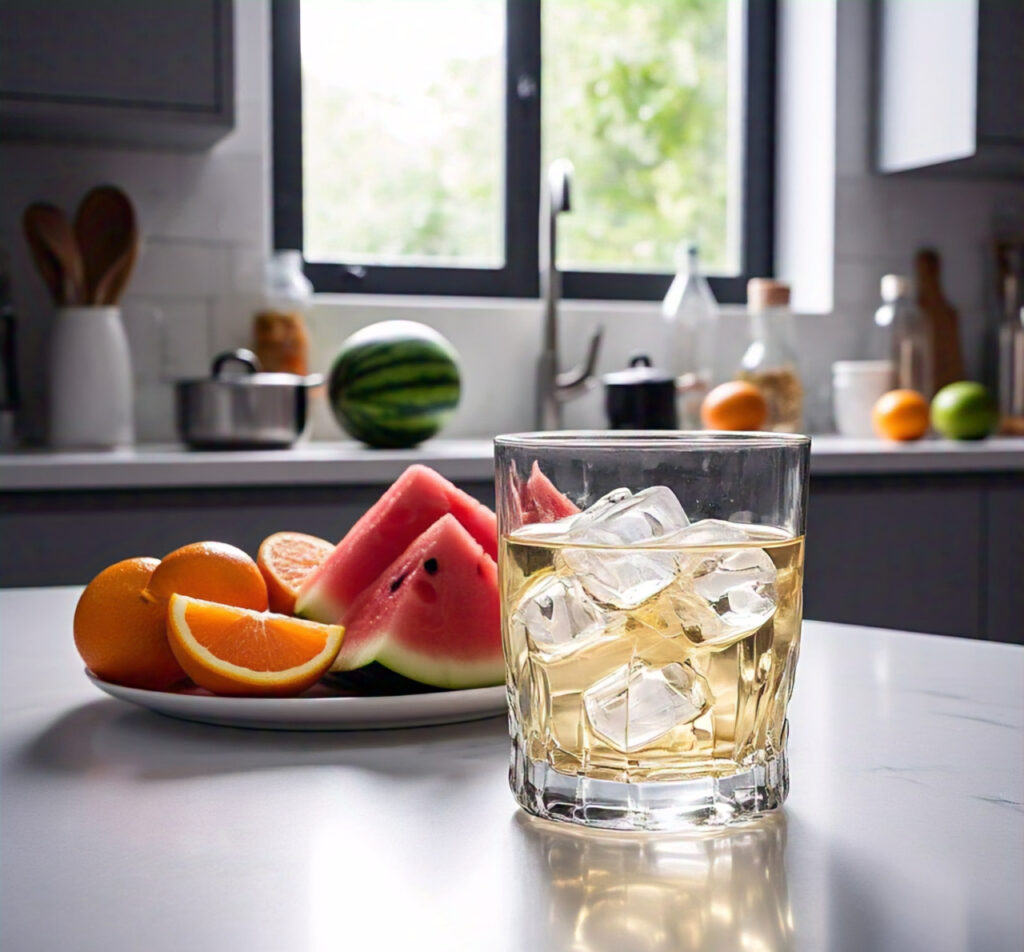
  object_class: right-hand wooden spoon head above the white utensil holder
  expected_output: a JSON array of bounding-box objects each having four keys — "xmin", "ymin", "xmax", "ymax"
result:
[{"xmin": 75, "ymin": 185, "xmax": 138, "ymax": 304}]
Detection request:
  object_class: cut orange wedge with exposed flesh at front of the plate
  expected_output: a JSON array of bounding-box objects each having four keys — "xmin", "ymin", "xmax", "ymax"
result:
[{"xmin": 167, "ymin": 595, "xmax": 345, "ymax": 697}]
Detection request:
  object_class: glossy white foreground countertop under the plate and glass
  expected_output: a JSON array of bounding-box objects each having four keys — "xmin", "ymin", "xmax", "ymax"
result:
[{"xmin": 0, "ymin": 589, "xmax": 1024, "ymax": 952}]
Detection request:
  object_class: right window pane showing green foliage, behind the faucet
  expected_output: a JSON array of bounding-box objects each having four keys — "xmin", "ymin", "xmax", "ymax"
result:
[{"xmin": 542, "ymin": 0, "xmax": 742, "ymax": 273}]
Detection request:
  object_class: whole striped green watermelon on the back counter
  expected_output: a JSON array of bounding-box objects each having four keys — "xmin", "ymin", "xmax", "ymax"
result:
[{"xmin": 328, "ymin": 320, "xmax": 461, "ymax": 448}]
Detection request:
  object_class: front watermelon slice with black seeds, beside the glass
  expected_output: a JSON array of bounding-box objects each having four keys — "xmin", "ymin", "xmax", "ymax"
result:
[{"xmin": 331, "ymin": 515, "xmax": 505, "ymax": 688}]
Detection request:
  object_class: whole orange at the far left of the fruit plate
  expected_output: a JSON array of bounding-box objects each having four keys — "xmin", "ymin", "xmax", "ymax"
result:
[{"xmin": 74, "ymin": 559, "xmax": 185, "ymax": 691}]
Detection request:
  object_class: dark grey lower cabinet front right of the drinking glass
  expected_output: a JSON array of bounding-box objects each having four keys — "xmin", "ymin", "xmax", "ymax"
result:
[{"xmin": 804, "ymin": 474, "xmax": 1024, "ymax": 644}]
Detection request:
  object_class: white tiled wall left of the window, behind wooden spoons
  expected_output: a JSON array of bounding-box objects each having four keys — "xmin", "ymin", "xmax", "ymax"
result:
[{"xmin": 0, "ymin": 0, "xmax": 270, "ymax": 440}]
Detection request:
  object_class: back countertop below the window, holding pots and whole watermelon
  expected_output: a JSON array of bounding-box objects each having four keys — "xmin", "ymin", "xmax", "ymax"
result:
[{"xmin": 0, "ymin": 436, "xmax": 1024, "ymax": 491}]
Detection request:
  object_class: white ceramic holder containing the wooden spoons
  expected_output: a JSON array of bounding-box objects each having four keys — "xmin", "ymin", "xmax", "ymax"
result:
[{"xmin": 50, "ymin": 307, "xmax": 135, "ymax": 448}]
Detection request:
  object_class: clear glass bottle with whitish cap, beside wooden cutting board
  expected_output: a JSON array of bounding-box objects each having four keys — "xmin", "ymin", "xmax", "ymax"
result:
[{"xmin": 874, "ymin": 274, "xmax": 935, "ymax": 400}]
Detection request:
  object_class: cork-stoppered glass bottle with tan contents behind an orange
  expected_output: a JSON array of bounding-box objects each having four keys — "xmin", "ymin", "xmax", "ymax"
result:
[{"xmin": 736, "ymin": 277, "xmax": 804, "ymax": 433}]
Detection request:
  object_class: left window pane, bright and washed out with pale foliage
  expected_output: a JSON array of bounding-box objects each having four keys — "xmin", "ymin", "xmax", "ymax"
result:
[{"xmin": 301, "ymin": 0, "xmax": 505, "ymax": 267}]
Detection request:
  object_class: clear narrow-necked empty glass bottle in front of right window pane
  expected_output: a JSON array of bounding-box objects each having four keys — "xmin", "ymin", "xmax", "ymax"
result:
[{"xmin": 662, "ymin": 245, "xmax": 718, "ymax": 430}]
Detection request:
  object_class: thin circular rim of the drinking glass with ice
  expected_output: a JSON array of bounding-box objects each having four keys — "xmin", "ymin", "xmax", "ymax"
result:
[{"xmin": 495, "ymin": 430, "xmax": 811, "ymax": 449}]
